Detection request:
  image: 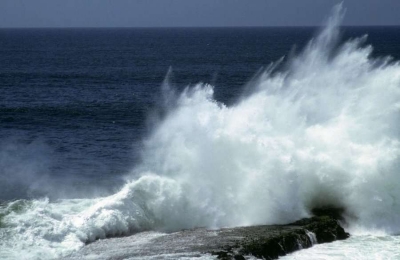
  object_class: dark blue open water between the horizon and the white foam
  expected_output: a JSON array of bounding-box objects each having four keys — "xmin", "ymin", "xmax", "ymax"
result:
[{"xmin": 0, "ymin": 27, "xmax": 400, "ymax": 201}]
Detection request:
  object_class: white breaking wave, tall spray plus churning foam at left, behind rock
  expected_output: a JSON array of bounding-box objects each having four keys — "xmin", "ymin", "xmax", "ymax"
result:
[{"xmin": 0, "ymin": 3, "xmax": 400, "ymax": 259}]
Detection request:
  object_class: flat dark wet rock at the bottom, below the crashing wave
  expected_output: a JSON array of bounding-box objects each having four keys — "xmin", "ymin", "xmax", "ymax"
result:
[{"xmin": 65, "ymin": 209, "xmax": 349, "ymax": 260}]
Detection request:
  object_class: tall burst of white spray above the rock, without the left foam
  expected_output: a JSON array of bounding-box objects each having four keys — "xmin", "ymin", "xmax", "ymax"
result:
[{"xmin": 138, "ymin": 6, "xmax": 400, "ymax": 232}]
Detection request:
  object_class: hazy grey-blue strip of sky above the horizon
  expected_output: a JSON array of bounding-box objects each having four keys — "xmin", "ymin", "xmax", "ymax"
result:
[{"xmin": 0, "ymin": 0, "xmax": 400, "ymax": 27}]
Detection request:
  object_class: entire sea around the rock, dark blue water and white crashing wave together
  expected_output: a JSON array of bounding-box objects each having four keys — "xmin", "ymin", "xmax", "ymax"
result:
[{"xmin": 0, "ymin": 6, "xmax": 400, "ymax": 259}]
